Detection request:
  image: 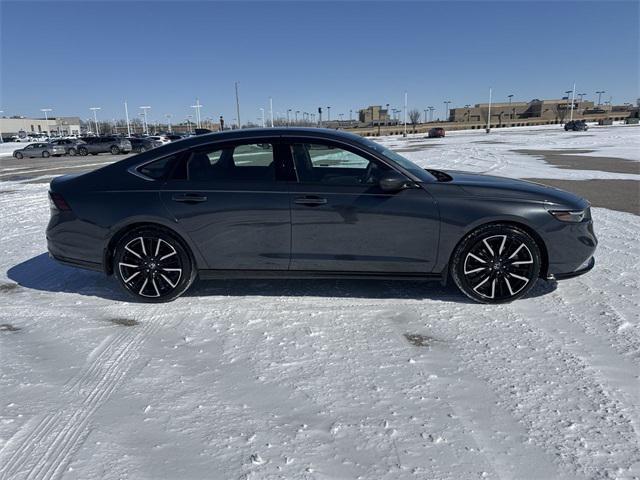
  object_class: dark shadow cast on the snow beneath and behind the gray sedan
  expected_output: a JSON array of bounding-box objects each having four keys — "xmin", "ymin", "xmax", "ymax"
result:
[{"xmin": 7, "ymin": 253, "xmax": 557, "ymax": 303}]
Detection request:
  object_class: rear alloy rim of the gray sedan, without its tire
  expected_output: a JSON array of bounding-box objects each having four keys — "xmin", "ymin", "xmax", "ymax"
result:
[{"xmin": 117, "ymin": 236, "xmax": 184, "ymax": 298}]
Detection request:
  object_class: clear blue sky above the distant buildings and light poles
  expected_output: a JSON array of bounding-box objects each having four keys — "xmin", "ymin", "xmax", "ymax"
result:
[{"xmin": 0, "ymin": 0, "xmax": 640, "ymax": 122}]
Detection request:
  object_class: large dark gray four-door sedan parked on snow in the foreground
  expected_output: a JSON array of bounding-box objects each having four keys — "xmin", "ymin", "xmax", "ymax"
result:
[{"xmin": 47, "ymin": 128, "xmax": 597, "ymax": 303}]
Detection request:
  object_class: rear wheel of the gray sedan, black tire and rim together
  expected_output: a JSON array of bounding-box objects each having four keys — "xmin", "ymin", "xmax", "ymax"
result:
[{"xmin": 113, "ymin": 227, "xmax": 197, "ymax": 303}]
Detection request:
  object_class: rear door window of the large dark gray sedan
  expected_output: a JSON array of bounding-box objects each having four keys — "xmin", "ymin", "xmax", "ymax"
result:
[{"xmin": 187, "ymin": 143, "xmax": 276, "ymax": 182}]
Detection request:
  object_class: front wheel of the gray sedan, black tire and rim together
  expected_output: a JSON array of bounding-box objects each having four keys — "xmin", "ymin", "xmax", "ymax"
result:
[{"xmin": 451, "ymin": 224, "xmax": 541, "ymax": 303}]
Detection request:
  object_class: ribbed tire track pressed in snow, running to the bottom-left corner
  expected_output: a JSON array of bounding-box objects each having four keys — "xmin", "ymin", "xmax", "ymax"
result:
[{"xmin": 0, "ymin": 315, "xmax": 162, "ymax": 480}]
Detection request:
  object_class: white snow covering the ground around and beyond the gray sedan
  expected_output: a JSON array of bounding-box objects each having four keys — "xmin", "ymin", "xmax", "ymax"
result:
[{"xmin": 0, "ymin": 127, "xmax": 640, "ymax": 480}]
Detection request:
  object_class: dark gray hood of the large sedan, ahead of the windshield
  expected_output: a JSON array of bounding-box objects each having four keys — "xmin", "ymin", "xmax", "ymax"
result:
[{"xmin": 444, "ymin": 170, "xmax": 589, "ymax": 209}]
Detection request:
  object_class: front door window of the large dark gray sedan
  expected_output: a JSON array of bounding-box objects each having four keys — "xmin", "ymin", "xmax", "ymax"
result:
[{"xmin": 291, "ymin": 143, "xmax": 390, "ymax": 185}]
